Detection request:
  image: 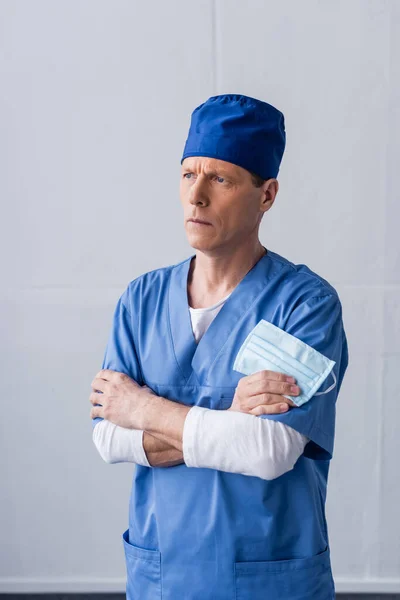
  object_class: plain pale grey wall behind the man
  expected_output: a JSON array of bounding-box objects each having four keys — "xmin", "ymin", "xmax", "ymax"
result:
[{"xmin": 0, "ymin": 0, "xmax": 400, "ymax": 592}]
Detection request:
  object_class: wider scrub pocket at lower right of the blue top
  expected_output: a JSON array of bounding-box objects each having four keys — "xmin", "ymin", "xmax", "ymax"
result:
[{"xmin": 235, "ymin": 547, "xmax": 335, "ymax": 600}]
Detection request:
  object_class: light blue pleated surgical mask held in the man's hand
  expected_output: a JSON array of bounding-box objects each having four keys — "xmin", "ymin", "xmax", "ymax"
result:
[{"xmin": 233, "ymin": 319, "xmax": 336, "ymax": 406}]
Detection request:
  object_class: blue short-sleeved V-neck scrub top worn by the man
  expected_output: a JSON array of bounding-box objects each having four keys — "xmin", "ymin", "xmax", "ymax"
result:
[{"xmin": 93, "ymin": 250, "xmax": 348, "ymax": 600}]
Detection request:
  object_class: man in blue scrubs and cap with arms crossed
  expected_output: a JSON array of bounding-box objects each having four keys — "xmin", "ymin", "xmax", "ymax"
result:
[{"xmin": 90, "ymin": 94, "xmax": 348, "ymax": 600}]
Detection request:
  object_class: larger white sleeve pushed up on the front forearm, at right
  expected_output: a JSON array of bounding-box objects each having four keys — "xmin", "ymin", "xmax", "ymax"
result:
[{"xmin": 182, "ymin": 406, "xmax": 309, "ymax": 479}]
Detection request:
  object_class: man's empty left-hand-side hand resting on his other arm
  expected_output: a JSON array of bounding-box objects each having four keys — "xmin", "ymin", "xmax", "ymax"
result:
[{"xmin": 89, "ymin": 369, "xmax": 156, "ymax": 429}]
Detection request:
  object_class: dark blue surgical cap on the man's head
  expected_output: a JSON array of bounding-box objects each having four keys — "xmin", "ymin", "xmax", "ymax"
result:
[{"xmin": 181, "ymin": 94, "xmax": 286, "ymax": 179}]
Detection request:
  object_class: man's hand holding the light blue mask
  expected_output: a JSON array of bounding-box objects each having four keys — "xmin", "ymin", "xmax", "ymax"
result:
[{"xmin": 228, "ymin": 370, "xmax": 301, "ymax": 415}]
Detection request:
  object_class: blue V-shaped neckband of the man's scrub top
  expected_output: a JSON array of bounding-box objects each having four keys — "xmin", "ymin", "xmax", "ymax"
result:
[{"xmin": 168, "ymin": 250, "xmax": 271, "ymax": 385}]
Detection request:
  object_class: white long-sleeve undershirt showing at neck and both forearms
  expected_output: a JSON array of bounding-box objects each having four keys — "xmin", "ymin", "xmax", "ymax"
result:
[{"xmin": 93, "ymin": 294, "xmax": 309, "ymax": 479}]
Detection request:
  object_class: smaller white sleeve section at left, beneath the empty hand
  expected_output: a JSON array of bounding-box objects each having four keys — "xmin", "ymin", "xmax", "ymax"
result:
[{"xmin": 93, "ymin": 419, "xmax": 151, "ymax": 467}]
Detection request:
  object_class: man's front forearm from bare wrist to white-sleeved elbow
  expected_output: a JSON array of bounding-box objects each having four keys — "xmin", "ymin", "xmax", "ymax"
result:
[{"xmin": 141, "ymin": 397, "xmax": 308, "ymax": 479}]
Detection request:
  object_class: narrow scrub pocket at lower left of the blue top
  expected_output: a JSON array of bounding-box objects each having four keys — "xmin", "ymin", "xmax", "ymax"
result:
[{"xmin": 122, "ymin": 529, "xmax": 161, "ymax": 600}]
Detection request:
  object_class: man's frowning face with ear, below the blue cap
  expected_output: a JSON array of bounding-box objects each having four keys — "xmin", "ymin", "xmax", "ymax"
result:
[{"xmin": 180, "ymin": 156, "xmax": 278, "ymax": 252}]
